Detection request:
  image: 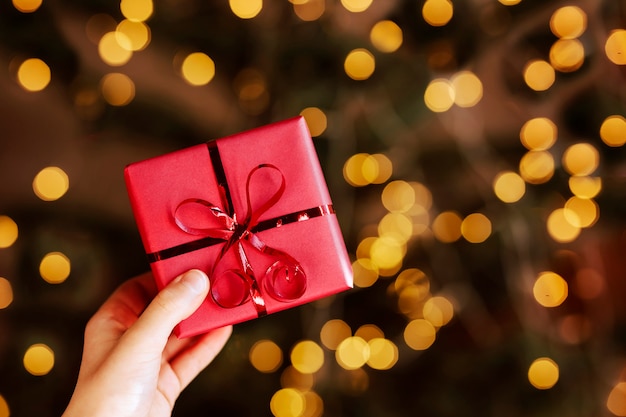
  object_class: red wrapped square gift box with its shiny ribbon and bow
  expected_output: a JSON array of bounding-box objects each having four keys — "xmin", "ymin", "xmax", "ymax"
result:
[{"xmin": 125, "ymin": 117, "xmax": 352, "ymax": 338}]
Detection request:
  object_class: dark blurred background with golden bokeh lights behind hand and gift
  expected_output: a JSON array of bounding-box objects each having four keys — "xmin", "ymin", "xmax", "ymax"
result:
[{"xmin": 0, "ymin": 0, "xmax": 626, "ymax": 417}]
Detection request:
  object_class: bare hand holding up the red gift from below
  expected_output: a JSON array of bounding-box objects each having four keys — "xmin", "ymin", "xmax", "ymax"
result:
[{"xmin": 63, "ymin": 270, "xmax": 232, "ymax": 417}]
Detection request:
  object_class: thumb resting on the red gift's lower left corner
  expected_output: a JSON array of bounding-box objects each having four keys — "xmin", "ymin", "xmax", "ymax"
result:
[{"xmin": 125, "ymin": 269, "xmax": 210, "ymax": 354}]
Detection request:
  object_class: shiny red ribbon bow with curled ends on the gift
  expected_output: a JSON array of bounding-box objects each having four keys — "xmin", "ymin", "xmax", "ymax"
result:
[{"xmin": 174, "ymin": 164, "xmax": 307, "ymax": 316}]
